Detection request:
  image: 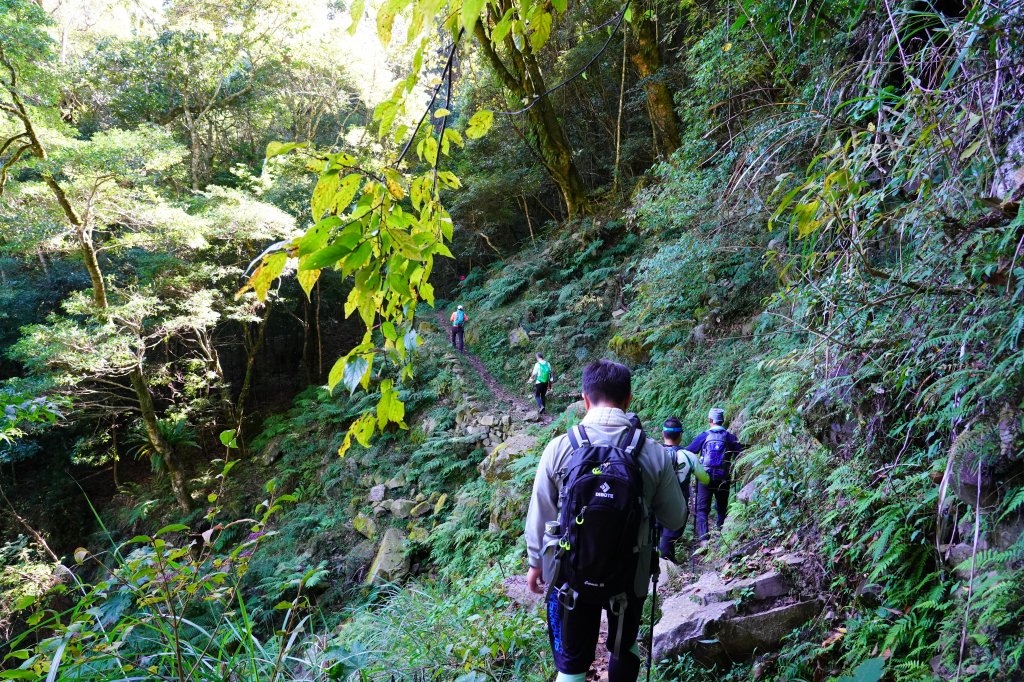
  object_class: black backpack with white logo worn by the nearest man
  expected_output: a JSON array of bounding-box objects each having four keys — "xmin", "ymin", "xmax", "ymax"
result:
[{"xmin": 557, "ymin": 425, "xmax": 652, "ymax": 608}]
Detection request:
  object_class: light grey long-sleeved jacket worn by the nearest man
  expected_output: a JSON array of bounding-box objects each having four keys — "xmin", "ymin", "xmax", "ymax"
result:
[{"xmin": 526, "ymin": 408, "xmax": 686, "ymax": 595}]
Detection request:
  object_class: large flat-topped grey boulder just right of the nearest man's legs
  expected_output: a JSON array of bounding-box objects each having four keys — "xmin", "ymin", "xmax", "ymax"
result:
[{"xmin": 653, "ymin": 571, "xmax": 822, "ymax": 663}]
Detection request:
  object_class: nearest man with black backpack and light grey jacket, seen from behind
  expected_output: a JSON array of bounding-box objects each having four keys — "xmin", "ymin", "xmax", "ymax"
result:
[{"xmin": 526, "ymin": 360, "xmax": 685, "ymax": 682}]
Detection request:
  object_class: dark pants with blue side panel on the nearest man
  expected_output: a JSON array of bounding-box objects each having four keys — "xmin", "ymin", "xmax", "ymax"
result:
[{"xmin": 547, "ymin": 590, "xmax": 644, "ymax": 682}]
